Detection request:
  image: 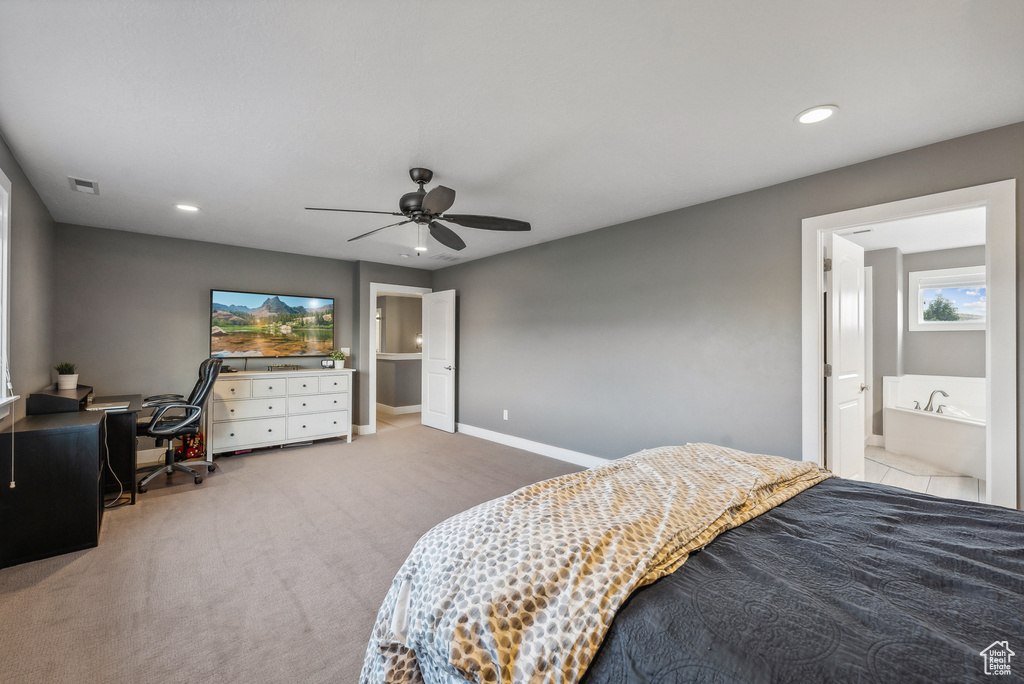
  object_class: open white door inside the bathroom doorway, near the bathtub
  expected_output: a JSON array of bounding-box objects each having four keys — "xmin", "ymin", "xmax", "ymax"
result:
[{"xmin": 825, "ymin": 233, "xmax": 868, "ymax": 479}]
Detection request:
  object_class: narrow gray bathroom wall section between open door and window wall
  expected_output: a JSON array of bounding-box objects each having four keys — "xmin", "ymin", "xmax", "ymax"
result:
[{"xmin": 864, "ymin": 247, "xmax": 904, "ymax": 434}]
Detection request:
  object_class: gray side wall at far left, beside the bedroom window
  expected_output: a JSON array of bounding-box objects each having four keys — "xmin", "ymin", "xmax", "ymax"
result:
[{"xmin": 0, "ymin": 132, "xmax": 58, "ymax": 429}]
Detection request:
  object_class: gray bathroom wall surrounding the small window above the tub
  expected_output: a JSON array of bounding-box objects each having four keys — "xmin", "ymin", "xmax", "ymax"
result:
[{"xmin": 903, "ymin": 244, "xmax": 983, "ymax": 378}]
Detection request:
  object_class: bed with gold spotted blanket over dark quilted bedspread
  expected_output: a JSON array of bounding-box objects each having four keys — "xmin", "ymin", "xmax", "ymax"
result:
[{"xmin": 360, "ymin": 444, "xmax": 1024, "ymax": 684}]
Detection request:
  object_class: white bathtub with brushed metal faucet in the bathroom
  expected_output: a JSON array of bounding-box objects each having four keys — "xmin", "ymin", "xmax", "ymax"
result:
[{"xmin": 882, "ymin": 375, "xmax": 986, "ymax": 480}]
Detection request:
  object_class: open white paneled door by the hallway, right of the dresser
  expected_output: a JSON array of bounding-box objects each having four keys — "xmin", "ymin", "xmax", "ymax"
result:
[{"xmin": 420, "ymin": 290, "xmax": 455, "ymax": 432}]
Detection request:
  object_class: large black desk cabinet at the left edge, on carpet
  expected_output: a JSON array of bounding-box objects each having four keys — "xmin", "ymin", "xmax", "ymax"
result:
[{"xmin": 0, "ymin": 411, "xmax": 104, "ymax": 567}]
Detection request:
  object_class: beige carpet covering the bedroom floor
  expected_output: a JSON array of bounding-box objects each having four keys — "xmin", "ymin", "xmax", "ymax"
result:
[{"xmin": 0, "ymin": 426, "xmax": 579, "ymax": 684}]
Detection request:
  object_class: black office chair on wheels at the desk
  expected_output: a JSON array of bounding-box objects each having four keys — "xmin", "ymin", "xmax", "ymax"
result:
[{"xmin": 136, "ymin": 358, "xmax": 223, "ymax": 493}]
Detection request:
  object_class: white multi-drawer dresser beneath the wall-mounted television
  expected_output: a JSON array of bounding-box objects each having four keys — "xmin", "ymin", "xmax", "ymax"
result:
[{"xmin": 207, "ymin": 369, "xmax": 353, "ymax": 455}]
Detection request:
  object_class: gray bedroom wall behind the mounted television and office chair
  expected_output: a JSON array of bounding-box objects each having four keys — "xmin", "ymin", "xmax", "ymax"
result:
[{"xmin": 54, "ymin": 223, "xmax": 355, "ymax": 395}]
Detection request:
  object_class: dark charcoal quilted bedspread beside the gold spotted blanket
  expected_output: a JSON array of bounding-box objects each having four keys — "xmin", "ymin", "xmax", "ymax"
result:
[{"xmin": 583, "ymin": 478, "xmax": 1024, "ymax": 684}]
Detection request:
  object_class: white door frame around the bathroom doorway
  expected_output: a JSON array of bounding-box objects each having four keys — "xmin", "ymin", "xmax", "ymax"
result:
[{"xmin": 801, "ymin": 179, "xmax": 1018, "ymax": 508}]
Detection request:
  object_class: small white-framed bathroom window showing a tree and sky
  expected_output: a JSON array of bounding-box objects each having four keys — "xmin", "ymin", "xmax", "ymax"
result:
[{"xmin": 907, "ymin": 266, "xmax": 986, "ymax": 332}]
